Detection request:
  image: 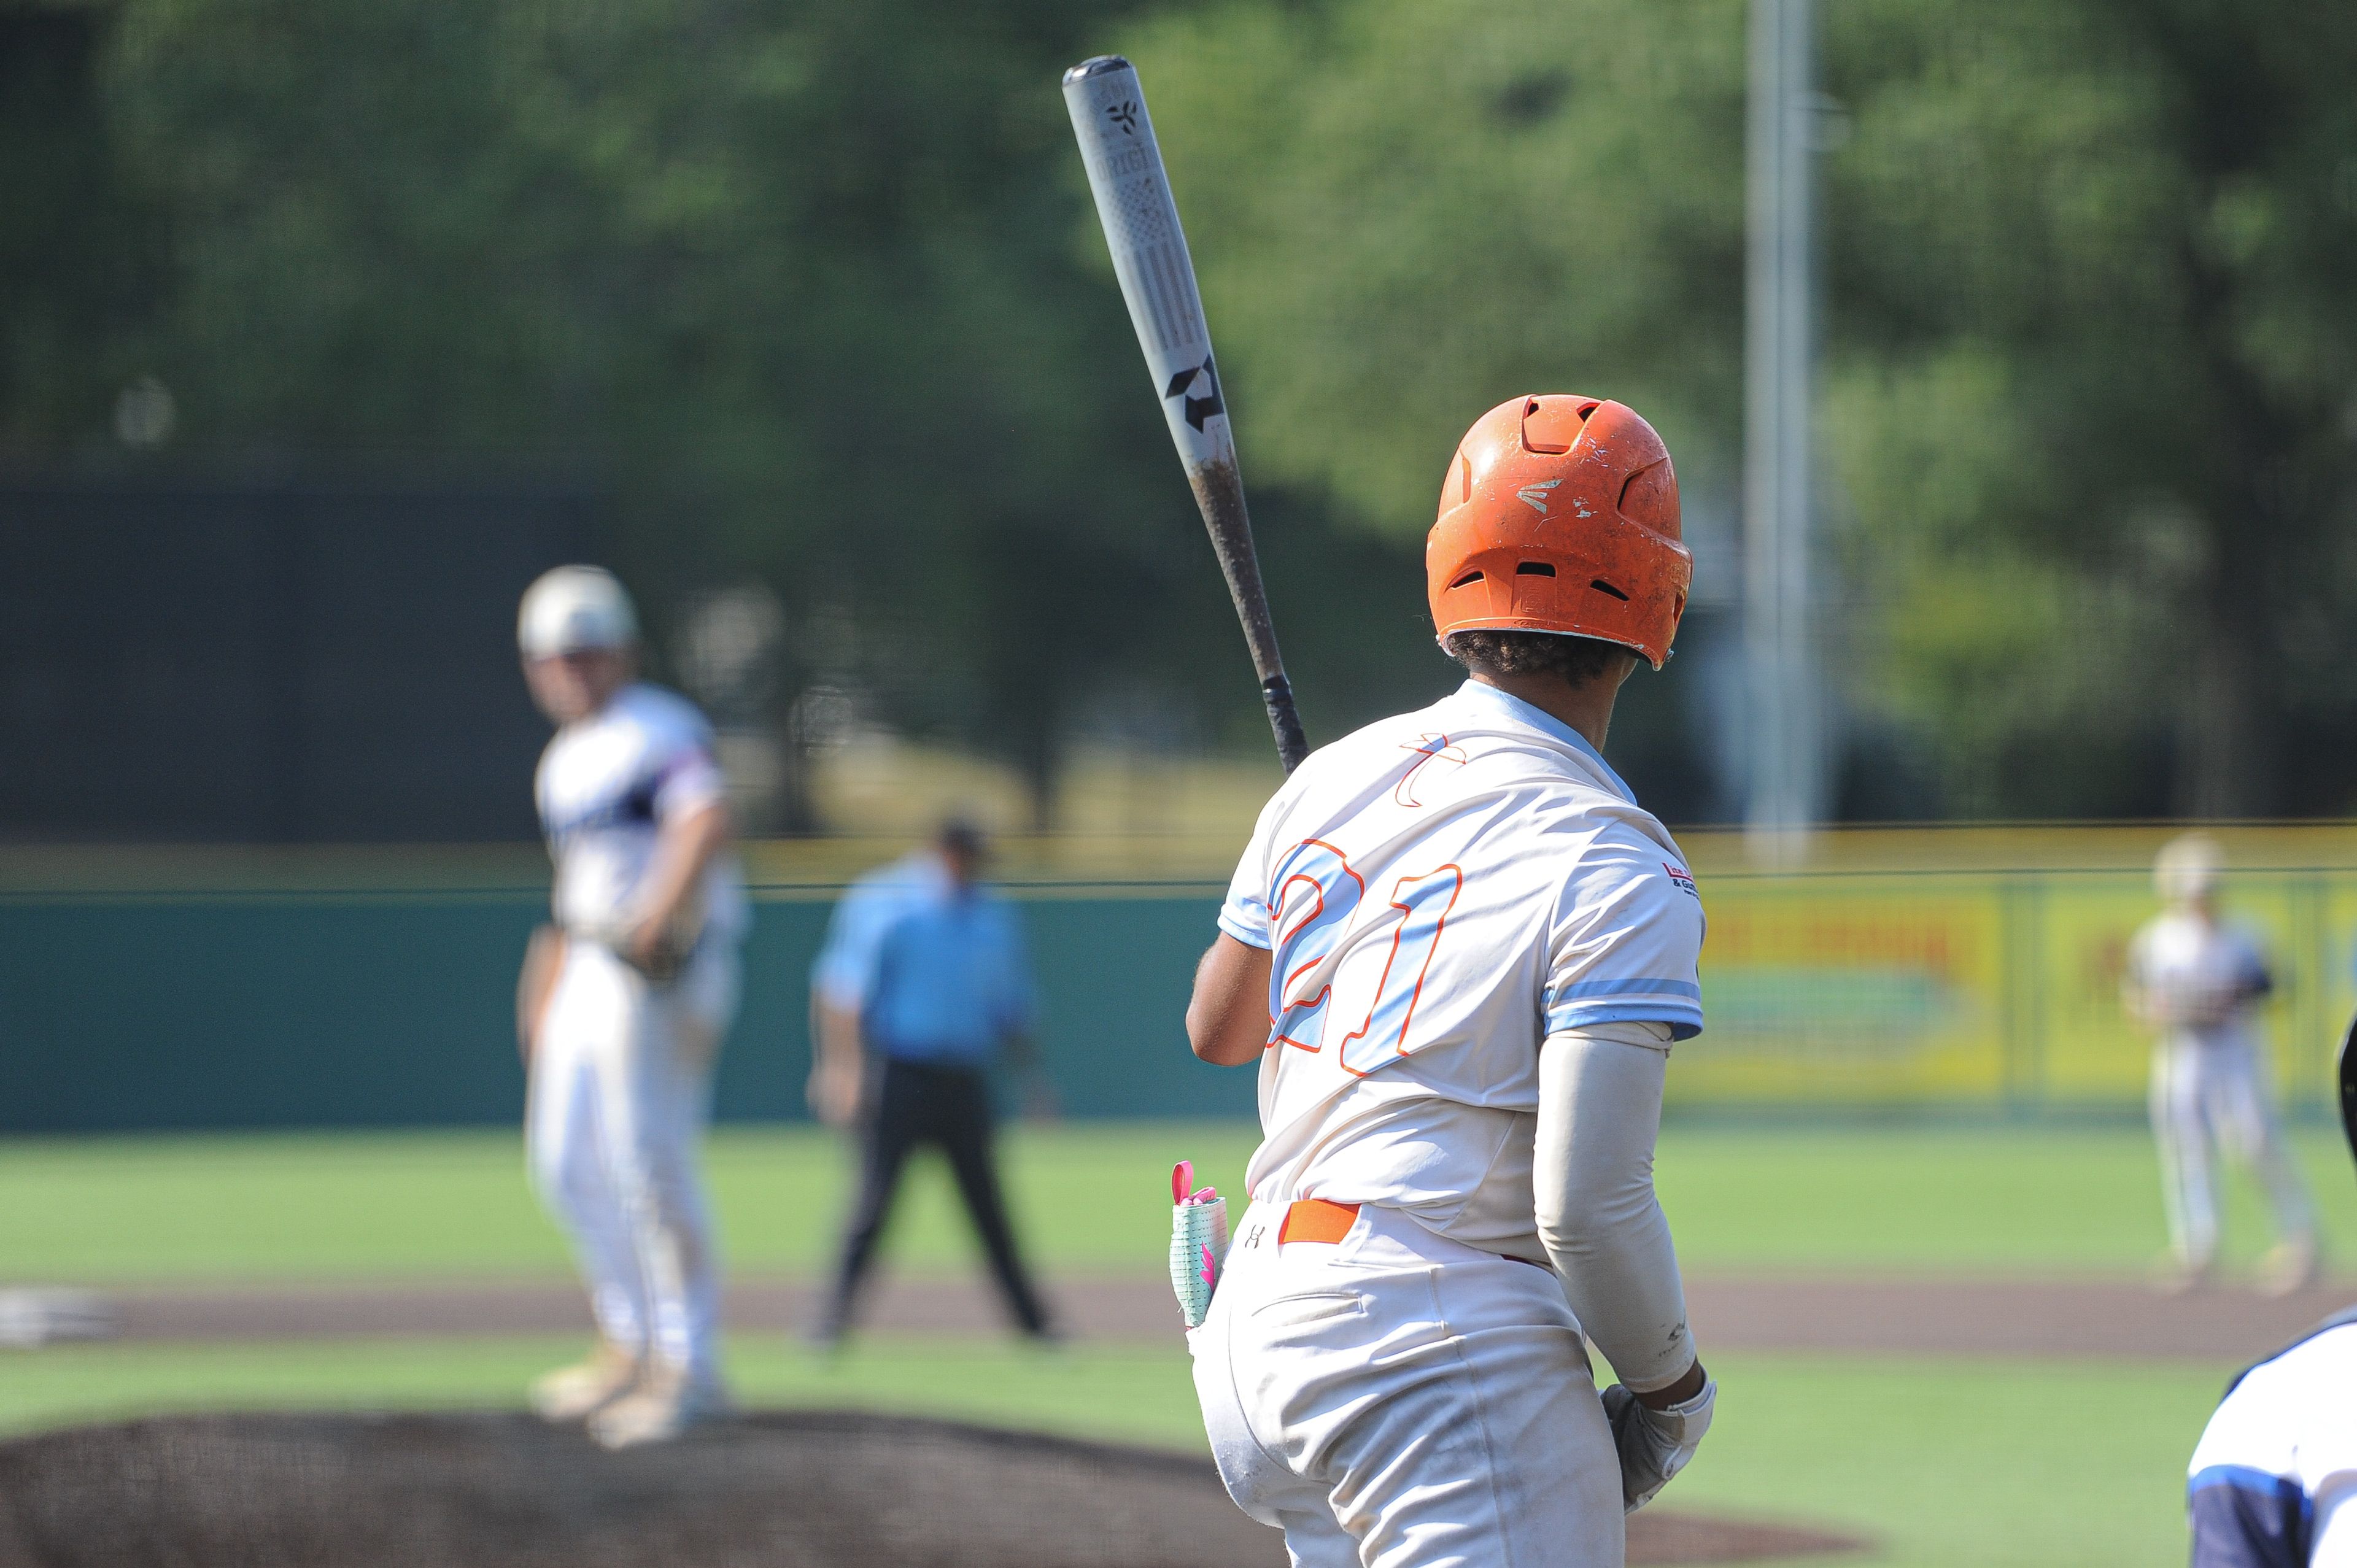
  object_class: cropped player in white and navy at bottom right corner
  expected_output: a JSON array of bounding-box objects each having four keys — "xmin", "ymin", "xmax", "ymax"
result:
[{"xmin": 2185, "ymin": 1025, "xmax": 2357, "ymax": 1568}]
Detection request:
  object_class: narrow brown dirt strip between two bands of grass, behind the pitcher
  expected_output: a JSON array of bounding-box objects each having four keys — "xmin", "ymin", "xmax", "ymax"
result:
[{"xmin": 60, "ymin": 1278, "xmax": 2357, "ymax": 1361}]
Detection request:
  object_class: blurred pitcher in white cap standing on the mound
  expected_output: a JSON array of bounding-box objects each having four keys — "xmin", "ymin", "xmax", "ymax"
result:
[{"xmin": 516, "ymin": 566, "xmax": 747, "ymax": 1448}]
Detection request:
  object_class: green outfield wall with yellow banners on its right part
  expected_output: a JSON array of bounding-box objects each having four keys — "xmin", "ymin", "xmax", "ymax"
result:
[{"xmin": 14, "ymin": 828, "xmax": 2357, "ymax": 1132}]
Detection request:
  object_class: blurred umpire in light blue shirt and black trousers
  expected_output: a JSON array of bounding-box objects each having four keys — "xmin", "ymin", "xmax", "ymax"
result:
[{"xmin": 811, "ymin": 821, "xmax": 1051, "ymax": 1346}]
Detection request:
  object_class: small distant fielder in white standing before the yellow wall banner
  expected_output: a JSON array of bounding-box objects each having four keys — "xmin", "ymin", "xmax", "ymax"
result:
[{"xmin": 2121, "ymin": 832, "xmax": 2317, "ymax": 1294}]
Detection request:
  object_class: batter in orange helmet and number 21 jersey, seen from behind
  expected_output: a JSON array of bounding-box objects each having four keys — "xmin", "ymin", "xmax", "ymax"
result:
[{"xmin": 1188, "ymin": 396, "xmax": 1716, "ymax": 1568}]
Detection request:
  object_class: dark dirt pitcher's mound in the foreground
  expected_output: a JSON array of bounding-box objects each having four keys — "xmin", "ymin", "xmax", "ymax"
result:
[{"xmin": 0, "ymin": 1415, "xmax": 1862, "ymax": 1568}]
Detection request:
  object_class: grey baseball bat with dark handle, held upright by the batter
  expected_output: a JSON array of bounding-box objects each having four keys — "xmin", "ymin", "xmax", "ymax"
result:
[{"xmin": 1063, "ymin": 54, "xmax": 1310, "ymax": 773}]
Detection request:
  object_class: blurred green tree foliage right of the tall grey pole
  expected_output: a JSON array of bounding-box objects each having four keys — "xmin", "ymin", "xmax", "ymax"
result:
[{"xmin": 1827, "ymin": 0, "xmax": 2357, "ymax": 816}]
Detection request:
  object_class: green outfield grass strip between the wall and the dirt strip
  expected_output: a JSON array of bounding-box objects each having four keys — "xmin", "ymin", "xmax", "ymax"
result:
[{"xmin": 0, "ymin": 1122, "xmax": 2357, "ymax": 1283}]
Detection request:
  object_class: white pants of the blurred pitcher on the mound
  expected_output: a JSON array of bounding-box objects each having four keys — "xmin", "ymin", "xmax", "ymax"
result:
[{"xmin": 523, "ymin": 941, "xmax": 738, "ymax": 1377}]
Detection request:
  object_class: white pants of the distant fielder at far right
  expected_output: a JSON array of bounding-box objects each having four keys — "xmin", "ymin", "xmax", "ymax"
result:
[{"xmin": 2152, "ymin": 1035, "xmax": 2315, "ymax": 1266}]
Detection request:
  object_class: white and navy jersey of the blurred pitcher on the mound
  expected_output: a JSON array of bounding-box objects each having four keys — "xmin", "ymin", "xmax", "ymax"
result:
[{"xmin": 533, "ymin": 684, "xmax": 747, "ymax": 936}]
